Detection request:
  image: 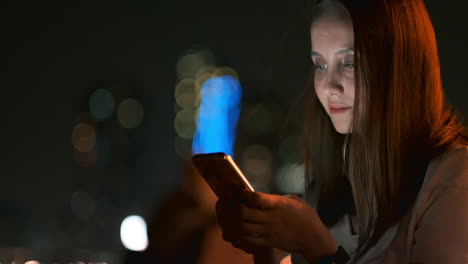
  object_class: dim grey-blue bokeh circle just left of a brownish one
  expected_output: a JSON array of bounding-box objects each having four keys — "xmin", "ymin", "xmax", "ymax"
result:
[{"xmin": 89, "ymin": 89, "xmax": 115, "ymax": 121}]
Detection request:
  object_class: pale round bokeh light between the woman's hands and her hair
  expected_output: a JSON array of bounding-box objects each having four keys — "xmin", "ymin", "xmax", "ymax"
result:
[{"xmin": 276, "ymin": 163, "xmax": 305, "ymax": 194}]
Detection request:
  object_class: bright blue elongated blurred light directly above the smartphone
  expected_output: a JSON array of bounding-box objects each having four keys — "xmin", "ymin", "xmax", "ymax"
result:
[{"xmin": 192, "ymin": 75, "xmax": 242, "ymax": 156}]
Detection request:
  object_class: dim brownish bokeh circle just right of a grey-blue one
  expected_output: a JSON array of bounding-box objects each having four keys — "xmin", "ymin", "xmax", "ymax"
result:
[{"xmin": 117, "ymin": 98, "xmax": 144, "ymax": 128}]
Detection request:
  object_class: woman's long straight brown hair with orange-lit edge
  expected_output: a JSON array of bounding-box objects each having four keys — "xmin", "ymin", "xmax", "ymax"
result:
[{"xmin": 304, "ymin": 0, "xmax": 468, "ymax": 259}]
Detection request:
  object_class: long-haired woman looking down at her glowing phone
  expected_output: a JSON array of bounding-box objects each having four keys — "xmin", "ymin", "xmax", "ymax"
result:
[{"xmin": 217, "ymin": 0, "xmax": 468, "ymax": 263}]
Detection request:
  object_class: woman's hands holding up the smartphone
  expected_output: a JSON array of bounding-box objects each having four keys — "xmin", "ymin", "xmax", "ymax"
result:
[{"xmin": 216, "ymin": 191, "xmax": 337, "ymax": 262}]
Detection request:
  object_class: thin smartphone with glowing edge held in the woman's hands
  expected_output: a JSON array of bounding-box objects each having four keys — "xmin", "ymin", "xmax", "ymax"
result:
[{"xmin": 192, "ymin": 152, "xmax": 254, "ymax": 199}]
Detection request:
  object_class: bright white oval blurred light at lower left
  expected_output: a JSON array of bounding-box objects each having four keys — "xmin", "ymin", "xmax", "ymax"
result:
[{"xmin": 120, "ymin": 215, "xmax": 148, "ymax": 251}]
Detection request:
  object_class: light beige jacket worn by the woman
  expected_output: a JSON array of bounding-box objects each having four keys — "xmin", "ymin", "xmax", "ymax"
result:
[{"xmin": 292, "ymin": 147, "xmax": 468, "ymax": 264}]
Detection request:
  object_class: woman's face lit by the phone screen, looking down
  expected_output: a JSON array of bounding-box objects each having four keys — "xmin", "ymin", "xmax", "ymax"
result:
[{"xmin": 310, "ymin": 10, "xmax": 354, "ymax": 134}]
